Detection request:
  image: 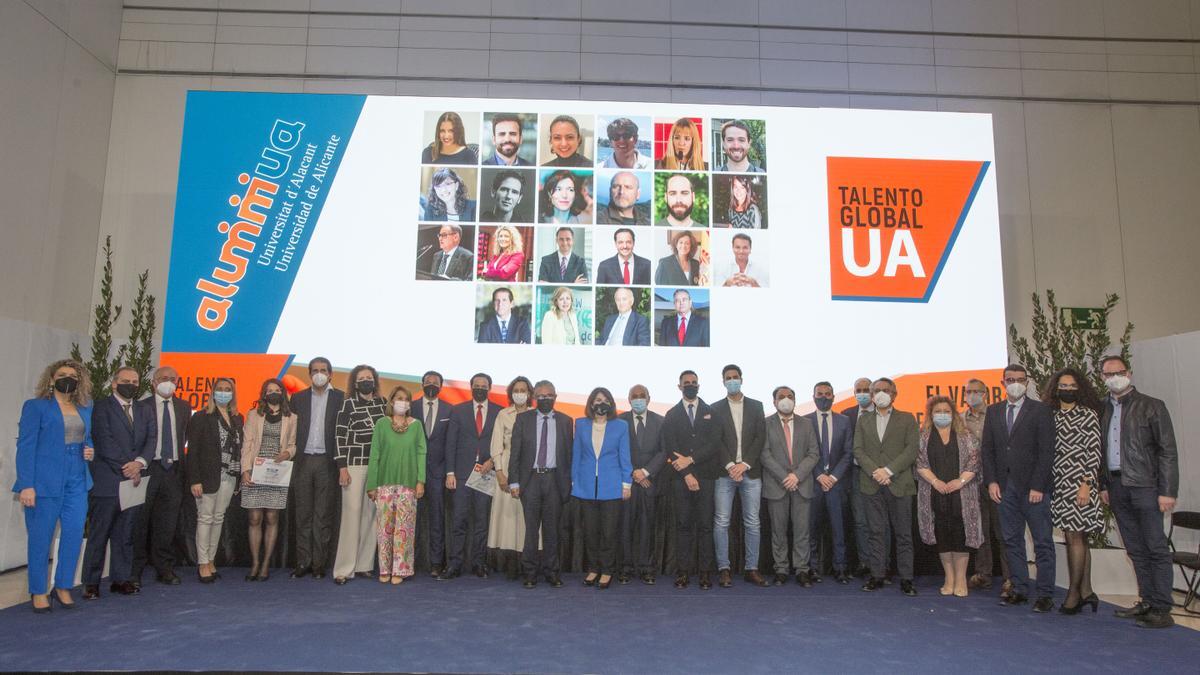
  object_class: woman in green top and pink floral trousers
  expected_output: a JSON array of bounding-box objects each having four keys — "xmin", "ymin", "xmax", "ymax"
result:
[{"xmin": 367, "ymin": 387, "xmax": 426, "ymax": 585}]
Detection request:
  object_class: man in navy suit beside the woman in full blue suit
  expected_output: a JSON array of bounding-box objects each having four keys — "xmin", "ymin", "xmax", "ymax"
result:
[{"xmin": 83, "ymin": 366, "xmax": 156, "ymax": 599}]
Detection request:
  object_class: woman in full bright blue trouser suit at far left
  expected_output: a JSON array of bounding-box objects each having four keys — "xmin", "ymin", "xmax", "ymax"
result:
[{"xmin": 12, "ymin": 360, "xmax": 94, "ymax": 614}]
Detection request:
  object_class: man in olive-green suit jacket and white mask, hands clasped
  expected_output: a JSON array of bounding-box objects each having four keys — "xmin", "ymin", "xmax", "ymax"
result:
[{"xmin": 854, "ymin": 377, "xmax": 919, "ymax": 596}]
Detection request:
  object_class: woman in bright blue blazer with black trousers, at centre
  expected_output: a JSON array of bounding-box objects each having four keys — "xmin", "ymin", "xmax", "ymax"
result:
[{"xmin": 571, "ymin": 387, "xmax": 634, "ymax": 589}]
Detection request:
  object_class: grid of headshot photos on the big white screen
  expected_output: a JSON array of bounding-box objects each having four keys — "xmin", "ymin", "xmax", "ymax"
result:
[{"xmin": 415, "ymin": 110, "xmax": 770, "ymax": 347}]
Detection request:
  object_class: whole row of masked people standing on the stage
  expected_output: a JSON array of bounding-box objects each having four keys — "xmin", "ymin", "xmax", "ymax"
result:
[{"xmin": 13, "ymin": 356, "xmax": 1178, "ymax": 627}]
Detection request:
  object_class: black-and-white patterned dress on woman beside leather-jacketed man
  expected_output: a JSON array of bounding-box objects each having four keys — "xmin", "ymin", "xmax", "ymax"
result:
[{"xmin": 1050, "ymin": 406, "xmax": 1104, "ymax": 532}]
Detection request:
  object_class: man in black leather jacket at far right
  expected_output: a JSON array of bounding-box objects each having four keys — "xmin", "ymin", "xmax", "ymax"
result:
[{"xmin": 1100, "ymin": 356, "xmax": 1180, "ymax": 628}]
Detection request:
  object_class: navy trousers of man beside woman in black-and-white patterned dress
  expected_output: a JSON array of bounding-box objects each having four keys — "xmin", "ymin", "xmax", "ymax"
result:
[{"xmin": 1000, "ymin": 483, "xmax": 1055, "ymax": 598}]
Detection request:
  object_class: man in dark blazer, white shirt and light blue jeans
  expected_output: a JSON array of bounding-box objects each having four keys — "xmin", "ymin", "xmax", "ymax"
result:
[{"xmin": 713, "ymin": 364, "xmax": 767, "ymax": 589}]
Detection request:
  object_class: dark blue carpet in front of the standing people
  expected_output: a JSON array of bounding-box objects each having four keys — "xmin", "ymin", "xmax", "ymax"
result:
[{"xmin": 0, "ymin": 569, "xmax": 1200, "ymax": 674}]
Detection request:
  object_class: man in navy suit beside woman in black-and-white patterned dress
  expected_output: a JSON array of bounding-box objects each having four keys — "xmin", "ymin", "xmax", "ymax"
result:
[{"xmin": 980, "ymin": 364, "xmax": 1055, "ymax": 613}]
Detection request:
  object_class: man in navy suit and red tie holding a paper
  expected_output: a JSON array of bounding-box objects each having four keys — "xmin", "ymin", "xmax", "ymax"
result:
[{"xmin": 438, "ymin": 372, "xmax": 500, "ymax": 581}]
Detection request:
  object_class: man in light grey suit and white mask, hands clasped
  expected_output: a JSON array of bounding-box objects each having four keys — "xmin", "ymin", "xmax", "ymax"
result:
[{"xmin": 761, "ymin": 387, "xmax": 821, "ymax": 586}]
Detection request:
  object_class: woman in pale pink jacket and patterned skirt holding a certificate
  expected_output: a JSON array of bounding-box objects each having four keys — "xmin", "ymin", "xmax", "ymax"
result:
[{"xmin": 241, "ymin": 378, "xmax": 296, "ymax": 581}]
